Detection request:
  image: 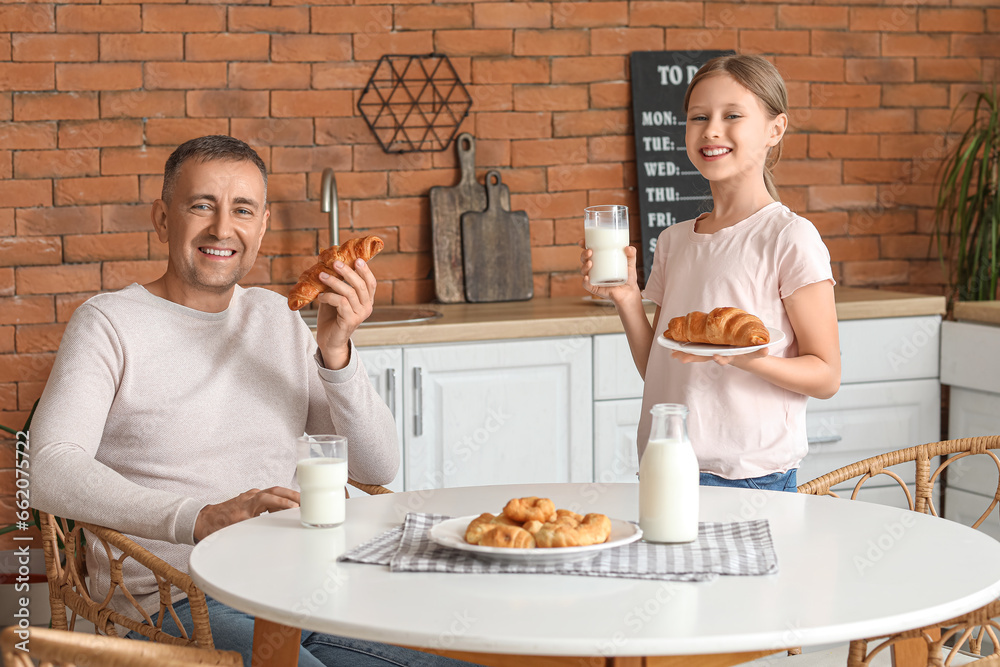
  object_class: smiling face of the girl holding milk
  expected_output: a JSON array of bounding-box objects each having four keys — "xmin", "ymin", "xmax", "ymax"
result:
[{"xmin": 685, "ymin": 74, "xmax": 788, "ymax": 192}]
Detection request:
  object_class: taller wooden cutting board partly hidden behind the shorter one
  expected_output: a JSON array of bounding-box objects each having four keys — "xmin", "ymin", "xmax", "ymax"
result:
[{"xmin": 430, "ymin": 132, "xmax": 510, "ymax": 303}]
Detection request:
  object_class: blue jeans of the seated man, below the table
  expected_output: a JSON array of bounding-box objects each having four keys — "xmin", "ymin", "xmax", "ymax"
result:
[{"xmin": 126, "ymin": 595, "xmax": 478, "ymax": 667}]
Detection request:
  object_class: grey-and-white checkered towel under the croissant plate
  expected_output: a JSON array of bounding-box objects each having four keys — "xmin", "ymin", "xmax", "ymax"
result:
[{"xmin": 339, "ymin": 512, "xmax": 778, "ymax": 581}]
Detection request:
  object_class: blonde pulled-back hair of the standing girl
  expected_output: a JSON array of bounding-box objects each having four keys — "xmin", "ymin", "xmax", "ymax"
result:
[{"xmin": 684, "ymin": 54, "xmax": 788, "ymax": 201}]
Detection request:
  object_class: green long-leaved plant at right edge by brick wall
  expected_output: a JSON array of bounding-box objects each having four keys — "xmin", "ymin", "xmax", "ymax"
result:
[{"xmin": 934, "ymin": 84, "xmax": 1000, "ymax": 310}]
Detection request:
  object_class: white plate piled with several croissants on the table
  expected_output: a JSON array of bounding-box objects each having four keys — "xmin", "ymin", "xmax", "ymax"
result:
[{"xmin": 430, "ymin": 496, "xmax": 642, "ymax": 565}]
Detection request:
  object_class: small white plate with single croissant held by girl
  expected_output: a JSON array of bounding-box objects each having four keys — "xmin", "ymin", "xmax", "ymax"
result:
[{"xmin": 656, "ymin": 306, "xmax": 785, "ymax": 357}]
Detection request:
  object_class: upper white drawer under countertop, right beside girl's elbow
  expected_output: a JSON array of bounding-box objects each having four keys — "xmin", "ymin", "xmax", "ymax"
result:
[{"xmin": 839, "ymin": 315, "xmax": 941, "ymax": 384}]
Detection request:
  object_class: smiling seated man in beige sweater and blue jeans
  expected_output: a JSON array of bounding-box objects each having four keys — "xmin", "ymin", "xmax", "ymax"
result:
[{"xmin": 31, "ymin": 136, "xmax": 468, "ymax": 666}]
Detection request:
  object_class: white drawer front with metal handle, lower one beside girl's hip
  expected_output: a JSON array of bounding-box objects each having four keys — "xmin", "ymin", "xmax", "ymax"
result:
[{"xmin": 798, "ymin": 380, "xmax": 941, "ymax": 486}]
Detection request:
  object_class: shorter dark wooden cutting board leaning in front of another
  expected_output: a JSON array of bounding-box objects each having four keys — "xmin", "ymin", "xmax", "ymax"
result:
[{"xmin": 462, "ymin": 171, "xmax": 534, "ymax": 302}]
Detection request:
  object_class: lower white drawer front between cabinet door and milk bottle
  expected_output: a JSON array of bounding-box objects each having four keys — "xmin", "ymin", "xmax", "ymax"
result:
[{"xmin": 594, "ymin": 398, "xmax": 642, "ymax": 484}]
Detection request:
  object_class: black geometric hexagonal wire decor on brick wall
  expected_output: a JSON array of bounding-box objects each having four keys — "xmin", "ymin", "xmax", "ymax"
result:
[{"xmin": 358, "ymin": 53, "xmax": 472, "ymax": 153}]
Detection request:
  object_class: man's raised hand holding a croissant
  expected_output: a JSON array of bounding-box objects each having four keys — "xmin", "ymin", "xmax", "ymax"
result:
[{"xmin": 316, "ymin": 259, "xmax": 375, "ymax": 370}]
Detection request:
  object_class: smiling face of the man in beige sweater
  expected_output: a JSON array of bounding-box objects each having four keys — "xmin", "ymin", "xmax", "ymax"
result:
[{"xmin": 153, "ymin": 160, "xmax": 269, "ymax": 295}]
